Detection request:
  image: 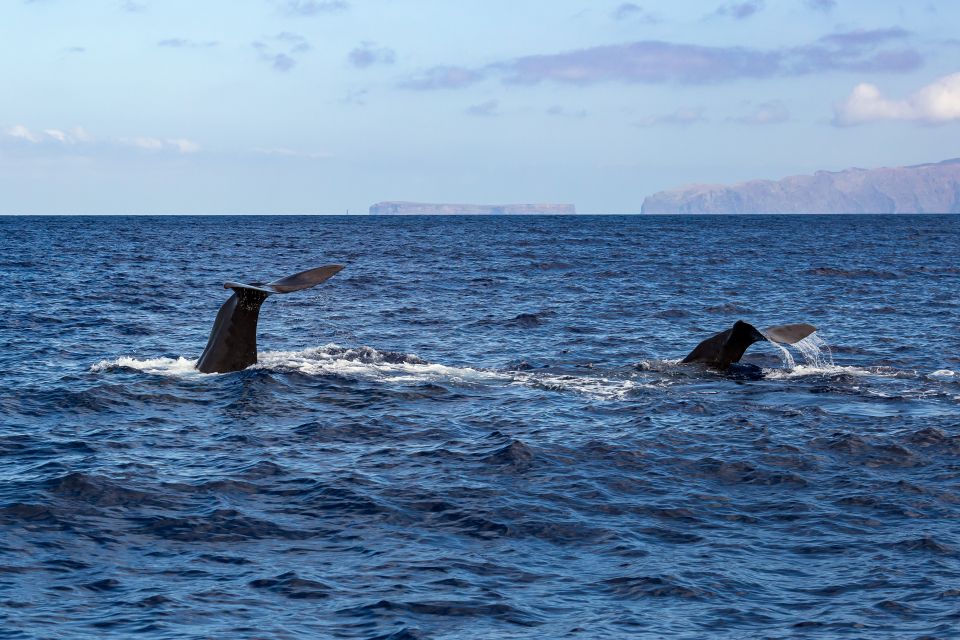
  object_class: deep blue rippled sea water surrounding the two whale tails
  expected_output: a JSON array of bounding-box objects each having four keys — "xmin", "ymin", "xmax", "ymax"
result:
[{"xmin": 0, "ymin": 216, "xmax": 960, "ymax": 639}]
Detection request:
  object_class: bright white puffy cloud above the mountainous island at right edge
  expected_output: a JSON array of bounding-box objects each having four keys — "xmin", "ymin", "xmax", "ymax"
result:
[{"xmin": 833, "ymin": 73, "xmax": 960, "ymax": 127}]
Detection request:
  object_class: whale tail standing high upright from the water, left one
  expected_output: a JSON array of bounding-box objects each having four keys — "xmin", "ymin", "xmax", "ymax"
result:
[{"xmin": 196, "ymin": 264, "xmax": 343, "ymax": 373}]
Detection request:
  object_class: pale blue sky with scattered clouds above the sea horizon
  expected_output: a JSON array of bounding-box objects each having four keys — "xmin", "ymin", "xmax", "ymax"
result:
[{"xmin": 0, "ymin": 0, "xmax": 960, "ymax": 214}]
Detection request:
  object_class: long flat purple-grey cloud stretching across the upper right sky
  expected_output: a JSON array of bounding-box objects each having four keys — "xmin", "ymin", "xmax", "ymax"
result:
[{"xmin": 401, "ymin": 28, "xmax": 923, "ymax": 90}]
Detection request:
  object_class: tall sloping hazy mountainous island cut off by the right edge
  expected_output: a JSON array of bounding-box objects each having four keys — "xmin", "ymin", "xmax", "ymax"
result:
[{"xmin": 641, "ymin": 158, "xmax": 960, "ymax": 213}]
